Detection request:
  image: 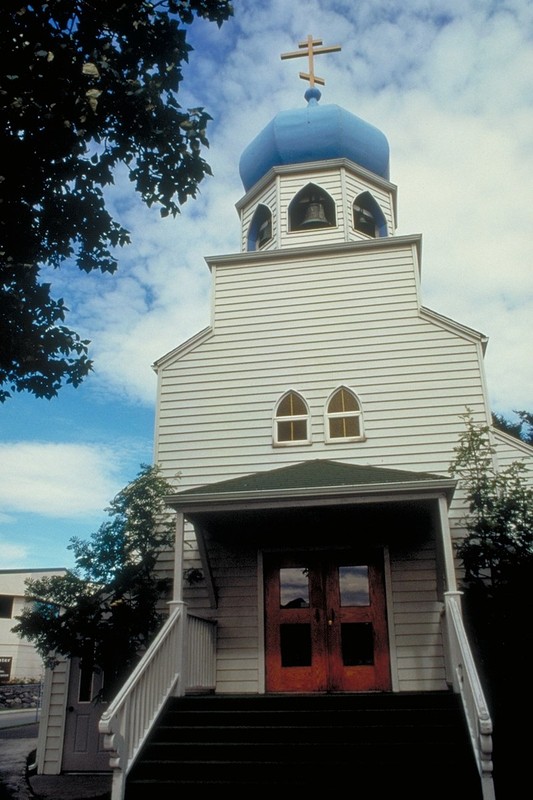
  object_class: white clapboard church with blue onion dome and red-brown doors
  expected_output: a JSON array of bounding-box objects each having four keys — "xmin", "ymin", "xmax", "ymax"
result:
[{"xmin": 37, "ymin": 37, "xmax": 531, "ymax": 800}]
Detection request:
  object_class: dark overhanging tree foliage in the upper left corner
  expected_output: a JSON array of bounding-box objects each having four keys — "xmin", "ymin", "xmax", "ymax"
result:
[{"xmin": 0, "ymin": 0, "xmax": 232, "ymax": 401}]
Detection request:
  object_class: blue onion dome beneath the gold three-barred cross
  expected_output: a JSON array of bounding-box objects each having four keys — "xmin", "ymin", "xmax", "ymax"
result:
[{"xmin": 239, "ymin": 87, "xmax": 389, "ymax": 191}]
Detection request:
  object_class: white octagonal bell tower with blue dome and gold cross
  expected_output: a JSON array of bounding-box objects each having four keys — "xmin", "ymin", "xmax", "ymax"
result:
[{"xmin": 237, "ymin": 36, "xmax": 396, "ymax": 252}]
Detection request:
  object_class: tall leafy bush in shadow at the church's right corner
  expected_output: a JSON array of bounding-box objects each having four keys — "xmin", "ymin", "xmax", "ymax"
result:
[{"xmin": 450, "ymin": 410, "xmax": 533, "ymax": 796}]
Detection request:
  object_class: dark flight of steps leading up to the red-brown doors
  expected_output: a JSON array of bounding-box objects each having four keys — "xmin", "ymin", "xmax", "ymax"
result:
[{"xmin": 126, "ymin": 692, "xmax": 481, "ymax": 800}]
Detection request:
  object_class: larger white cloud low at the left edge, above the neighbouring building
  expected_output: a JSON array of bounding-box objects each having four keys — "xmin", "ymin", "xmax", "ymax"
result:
[{"xmin": 0, "ymin": 442, "xmax": 125, "ymax": 519}]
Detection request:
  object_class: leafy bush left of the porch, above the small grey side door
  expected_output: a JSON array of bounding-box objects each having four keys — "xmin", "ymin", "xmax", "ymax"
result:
[{"xmin": 13, "ymin": 465, "xmax": 177, "ymax": 697}]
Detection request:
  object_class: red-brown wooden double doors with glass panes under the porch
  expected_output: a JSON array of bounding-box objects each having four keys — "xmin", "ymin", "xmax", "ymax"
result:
[{"xmin": 264, "ymin": 551, "xmax": 390, "ymax": 692}]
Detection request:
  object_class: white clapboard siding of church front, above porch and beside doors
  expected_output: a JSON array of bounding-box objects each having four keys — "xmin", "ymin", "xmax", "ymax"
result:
[{"xmin": 156, "ymin": 222, "xmax": 494, "ymax": 692}]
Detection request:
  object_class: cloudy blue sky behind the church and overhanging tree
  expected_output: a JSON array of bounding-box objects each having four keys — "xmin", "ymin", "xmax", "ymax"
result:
[{"xmin": 0, "ymin": 0, "xmax": 533, "ymax": 569}]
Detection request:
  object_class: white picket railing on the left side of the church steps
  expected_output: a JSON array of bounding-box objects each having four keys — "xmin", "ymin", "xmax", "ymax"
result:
[{"xmin": 99, "ymin": 603, "xmax": 216, "ymax": 800}]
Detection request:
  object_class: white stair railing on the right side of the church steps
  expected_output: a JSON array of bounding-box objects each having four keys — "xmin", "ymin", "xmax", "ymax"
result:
[{"xmin": 444, "ymin": 592, "xmax": 495, "ymax": 800}]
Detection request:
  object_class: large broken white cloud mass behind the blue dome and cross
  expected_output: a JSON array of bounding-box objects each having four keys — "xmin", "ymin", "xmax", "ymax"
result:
[{"xmin": 28, "ymin": 0, "xmax": 533, "ymax": 410}]
